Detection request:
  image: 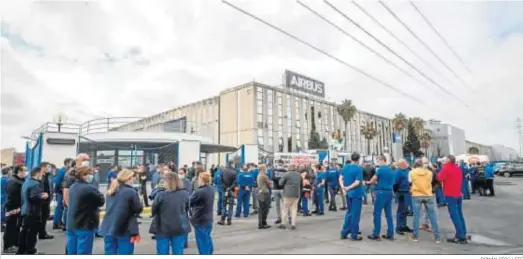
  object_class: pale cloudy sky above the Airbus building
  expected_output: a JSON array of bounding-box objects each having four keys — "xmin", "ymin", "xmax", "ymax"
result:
[{"xmin": 1, "ymin": 0, "xmax": 523, "ymax": 151}]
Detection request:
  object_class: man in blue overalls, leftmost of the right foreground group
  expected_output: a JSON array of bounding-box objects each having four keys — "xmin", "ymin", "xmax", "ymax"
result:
[{"xmin": 340, "ymin": 153, "xmax": 365, "ymax": 241}]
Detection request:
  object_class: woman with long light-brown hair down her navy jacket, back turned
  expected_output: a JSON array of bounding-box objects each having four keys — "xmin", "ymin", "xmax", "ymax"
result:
[{"xmin": 149, "ymin": 172, "xmax": 190, "ymax": 255}]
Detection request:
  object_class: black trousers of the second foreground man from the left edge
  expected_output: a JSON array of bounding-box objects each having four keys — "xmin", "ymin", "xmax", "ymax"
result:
[{"xmin": 16, "ymin": 216, "xmax": 40, "ymax": 254}]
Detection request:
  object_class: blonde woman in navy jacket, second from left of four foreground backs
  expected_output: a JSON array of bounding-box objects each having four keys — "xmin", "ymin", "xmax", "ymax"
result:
[{"xmin": 100, "ymin": 169, "xmax": 143, "ymax": 255}]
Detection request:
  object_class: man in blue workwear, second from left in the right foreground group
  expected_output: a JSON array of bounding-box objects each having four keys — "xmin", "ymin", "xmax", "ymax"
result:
[{"xmin": 368, "ymin": 155, "xmax": 394, "ymax": 241}]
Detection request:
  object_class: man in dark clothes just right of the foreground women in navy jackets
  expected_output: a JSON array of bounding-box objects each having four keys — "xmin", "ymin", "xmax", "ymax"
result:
[{"xmin": 218, "ymin": 161, "xmax": 236, "ymax": 225}]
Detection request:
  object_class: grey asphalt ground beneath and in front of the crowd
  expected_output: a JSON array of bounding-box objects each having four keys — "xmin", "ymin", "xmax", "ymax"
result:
[{"xmin": 4, "ymin": 178, "xmax": 523, "ymax": 254}]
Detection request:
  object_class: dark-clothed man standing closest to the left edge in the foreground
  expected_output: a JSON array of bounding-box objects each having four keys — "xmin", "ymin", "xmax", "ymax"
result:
[{"xmin": 3, "ymin": 166, "xmax": 27, "ymax": 253}]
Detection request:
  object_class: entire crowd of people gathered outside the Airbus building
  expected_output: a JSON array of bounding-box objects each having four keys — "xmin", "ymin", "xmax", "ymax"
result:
[{"xmin": 1, "ymin": 153, "xmax": 500, "ymax": 255}]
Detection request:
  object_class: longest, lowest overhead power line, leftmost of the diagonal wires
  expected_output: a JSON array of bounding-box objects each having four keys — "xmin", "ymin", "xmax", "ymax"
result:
[{"xmin": 222, "ymin": 0, "xmax": 433, "ymax": 108}]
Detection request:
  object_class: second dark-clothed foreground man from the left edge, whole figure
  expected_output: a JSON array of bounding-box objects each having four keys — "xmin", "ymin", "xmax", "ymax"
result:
[{"xmin": 16, "ymin": 167, "xmax": 49, "ymax": 254}]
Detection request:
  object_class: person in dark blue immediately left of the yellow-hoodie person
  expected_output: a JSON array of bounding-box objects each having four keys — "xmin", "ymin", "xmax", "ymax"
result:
[{"xmin": 394, "ymin": 159, "xmax": 412, "ymax": 235}]
